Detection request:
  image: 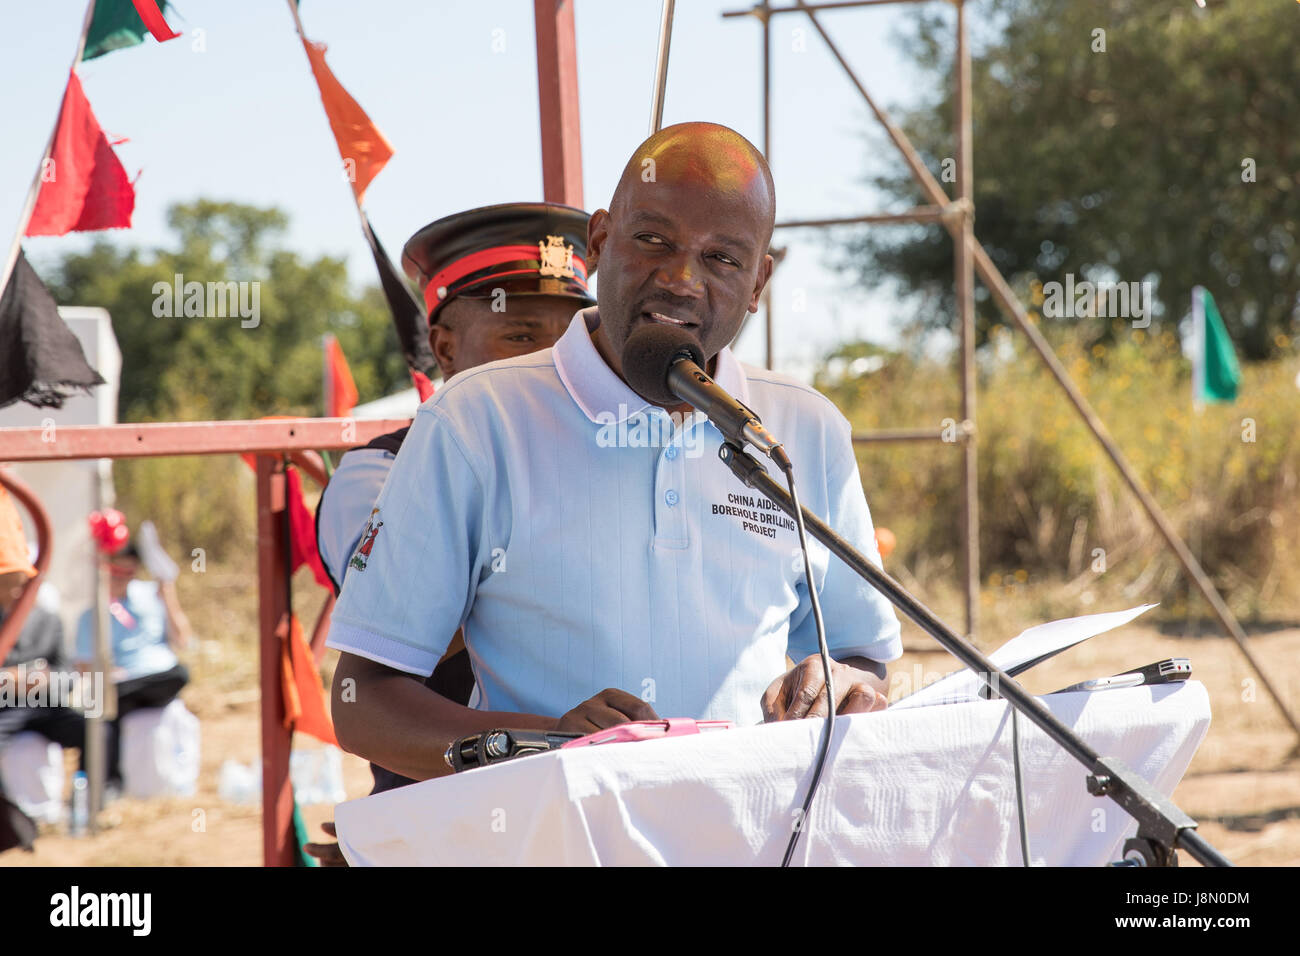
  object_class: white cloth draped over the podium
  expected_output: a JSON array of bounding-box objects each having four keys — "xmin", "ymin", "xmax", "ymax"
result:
[{"xmin": 335, "ymin": 682, "xmax": 1210, "ymax": 866}]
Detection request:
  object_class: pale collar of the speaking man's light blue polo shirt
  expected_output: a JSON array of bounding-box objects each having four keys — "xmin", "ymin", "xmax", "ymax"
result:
[{"xmin": 551, "ymin": 306, "xmax": 749, "ymax": 424}]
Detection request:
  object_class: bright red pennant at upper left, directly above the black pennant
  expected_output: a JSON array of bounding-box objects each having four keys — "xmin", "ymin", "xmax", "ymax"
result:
[{"xmin": 26, "ymin": 70, "xmax": 135, "ymax": 235}]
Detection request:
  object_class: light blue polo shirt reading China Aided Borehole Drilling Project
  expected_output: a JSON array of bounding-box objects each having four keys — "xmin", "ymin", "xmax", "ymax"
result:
[{"xmin": 328, "ymin": 307, "xmax": 902, "ymax": 724}]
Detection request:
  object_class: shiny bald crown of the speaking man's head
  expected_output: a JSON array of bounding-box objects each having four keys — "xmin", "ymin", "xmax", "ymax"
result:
[{"xmin": 610, "ymin": 122, "xmax": 776, "ymax": 246}]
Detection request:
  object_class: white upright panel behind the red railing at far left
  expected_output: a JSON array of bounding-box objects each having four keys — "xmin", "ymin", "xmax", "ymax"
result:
[{"xmin": 0, "ymin": 307, "xmax": 122, "ymax": 649}]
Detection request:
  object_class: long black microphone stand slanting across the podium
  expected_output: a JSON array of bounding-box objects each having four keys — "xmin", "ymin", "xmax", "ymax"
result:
[{"xmin": 718, "ymin": 441, "xmax": 1232, "ymax": 866}]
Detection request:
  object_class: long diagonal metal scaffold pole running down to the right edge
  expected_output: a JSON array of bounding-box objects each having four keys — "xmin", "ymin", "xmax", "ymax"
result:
[{"xmin": 780, "ymin": 0, "xmax": 1300, "ymax": 737}]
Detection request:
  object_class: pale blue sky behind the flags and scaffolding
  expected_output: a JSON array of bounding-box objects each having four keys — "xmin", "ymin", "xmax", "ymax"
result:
[{"xmin": 0, "ymin": 0, "xmax": 946, "ymax": 385}]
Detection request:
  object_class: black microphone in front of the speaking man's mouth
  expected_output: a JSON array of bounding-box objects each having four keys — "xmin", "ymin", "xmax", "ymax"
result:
[{"xmin": 623, "ymin": 325, "xmax": 790, "ymax": 471}]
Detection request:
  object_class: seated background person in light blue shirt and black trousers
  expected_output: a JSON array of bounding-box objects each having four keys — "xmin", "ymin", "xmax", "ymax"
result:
[{"xmin": 77, "ymin": 522, "xmax": 190, "ymax": 790}]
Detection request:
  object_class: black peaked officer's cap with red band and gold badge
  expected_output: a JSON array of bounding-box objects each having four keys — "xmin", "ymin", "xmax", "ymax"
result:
[{"xmin": 402, "ymin": 203, "xmax": 595, "ymax": 325}]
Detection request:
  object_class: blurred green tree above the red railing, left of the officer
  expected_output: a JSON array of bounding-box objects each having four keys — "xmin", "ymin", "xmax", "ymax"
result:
[{"xmin": 49, "ymin": 199, "xmax": 407, "ymax": 421}]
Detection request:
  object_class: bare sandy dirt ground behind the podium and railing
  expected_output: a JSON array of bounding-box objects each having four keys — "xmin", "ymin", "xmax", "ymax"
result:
[{"xmin": 0, "ymin": 626, "xmax": 1300, "ymax": 866}]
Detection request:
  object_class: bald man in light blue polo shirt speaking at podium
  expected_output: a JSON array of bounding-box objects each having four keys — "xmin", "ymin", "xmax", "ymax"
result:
[{"xmin": 328, "ymin": 124, "xmax": 902, "ymax": 779}]
